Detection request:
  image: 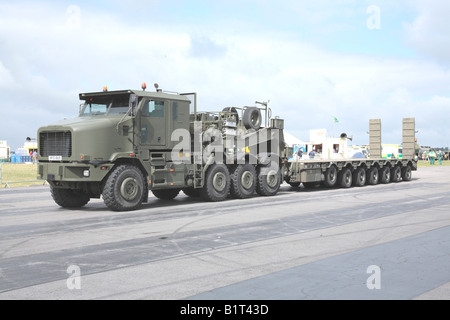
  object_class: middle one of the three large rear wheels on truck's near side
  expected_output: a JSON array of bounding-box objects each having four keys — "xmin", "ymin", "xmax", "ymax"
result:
[{"xmin": 230, "ymin": 163, "xmax": 256, "ymax": 199}]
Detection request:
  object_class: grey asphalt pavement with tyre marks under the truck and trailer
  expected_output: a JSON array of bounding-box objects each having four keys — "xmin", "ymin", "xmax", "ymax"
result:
[{"xmin": 0, "ymin": 166, "xmax": 450, "ymax": 300}]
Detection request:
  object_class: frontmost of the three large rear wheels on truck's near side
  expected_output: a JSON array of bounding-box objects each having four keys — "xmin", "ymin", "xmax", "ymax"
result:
[{"xmin": 200, "ymin": 164, "xmax": 230, "ymax": 202}]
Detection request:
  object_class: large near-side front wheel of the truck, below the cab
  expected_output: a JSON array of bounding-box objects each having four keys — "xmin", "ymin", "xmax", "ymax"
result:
[{"xmin": 102, "ymin": 165, "xmax": 144, "ymax": 211}]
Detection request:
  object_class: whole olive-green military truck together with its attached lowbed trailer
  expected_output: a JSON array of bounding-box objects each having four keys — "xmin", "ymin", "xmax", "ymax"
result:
[{"xmin": 37, "ymin": 84, "xmax": 417, "ymax": 211}]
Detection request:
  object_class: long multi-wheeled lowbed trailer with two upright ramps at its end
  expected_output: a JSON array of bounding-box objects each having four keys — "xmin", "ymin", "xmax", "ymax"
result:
[{"xmin": 283, "ymin": 118, "xmax": 417, "ymax": 188}]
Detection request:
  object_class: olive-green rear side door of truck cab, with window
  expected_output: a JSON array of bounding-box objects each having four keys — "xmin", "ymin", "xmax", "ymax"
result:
[{"xmin": 140, "ymin": 100, "xmax": 169, "ymax": 148}]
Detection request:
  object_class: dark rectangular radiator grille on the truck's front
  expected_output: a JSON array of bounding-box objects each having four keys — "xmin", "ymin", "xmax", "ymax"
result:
[{"xmin": 39, "ymin": 131, "xmax": 72, "ymax": 158}]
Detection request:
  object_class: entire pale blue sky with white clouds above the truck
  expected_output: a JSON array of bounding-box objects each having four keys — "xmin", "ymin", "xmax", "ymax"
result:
[{"xmin": 0, "ymin": 0, "xmax": 450, "ymax": 150}]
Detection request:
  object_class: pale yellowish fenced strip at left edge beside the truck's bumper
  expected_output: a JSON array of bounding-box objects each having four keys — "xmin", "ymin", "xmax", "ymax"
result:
[{"xmin": 0, "ymin": 163, "xmax": 46, "ymax": 188}]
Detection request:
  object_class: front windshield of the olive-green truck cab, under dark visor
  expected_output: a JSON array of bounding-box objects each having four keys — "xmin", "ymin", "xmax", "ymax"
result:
[{"xmin": 80, "ymin": 95, "xmax": 129, "ymax": 117}]
